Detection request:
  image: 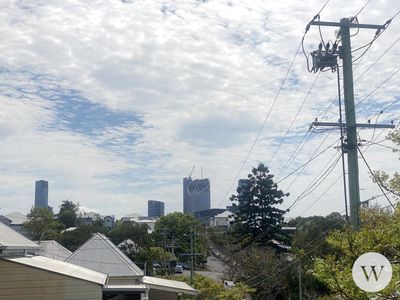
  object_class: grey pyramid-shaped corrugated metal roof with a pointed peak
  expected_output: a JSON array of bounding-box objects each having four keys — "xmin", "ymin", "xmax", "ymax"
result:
[{"xmin": 65, "ymin": 233, "xmax": 143, "ymax": 277}]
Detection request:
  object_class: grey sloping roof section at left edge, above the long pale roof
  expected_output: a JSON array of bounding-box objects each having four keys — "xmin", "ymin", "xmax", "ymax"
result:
[{"xmin": 0, "ymin": 222, "xmax": 39, "ymax": 250}]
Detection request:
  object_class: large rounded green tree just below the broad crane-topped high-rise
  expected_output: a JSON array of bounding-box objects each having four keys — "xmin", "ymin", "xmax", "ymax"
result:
[{"xmin": 152, "ymin": 212, "xmax": 206, "ymax": 258}]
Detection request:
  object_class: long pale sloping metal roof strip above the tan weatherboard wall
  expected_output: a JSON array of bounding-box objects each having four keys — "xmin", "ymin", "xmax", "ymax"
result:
[{"xmin": 3, "ymin": 256, "xmax": 107, "ymax": 285}]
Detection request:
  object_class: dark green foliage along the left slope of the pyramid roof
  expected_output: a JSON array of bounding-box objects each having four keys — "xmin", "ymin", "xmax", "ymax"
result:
[{"xmin": 58, "ymin": 222, "xmax": 107, "ymax": 252}]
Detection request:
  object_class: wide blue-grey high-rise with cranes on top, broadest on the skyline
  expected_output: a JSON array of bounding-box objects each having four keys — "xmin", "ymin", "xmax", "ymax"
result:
[{"xmin": 183, "ymin": 176, "xmax": 211, "ymax": 215}]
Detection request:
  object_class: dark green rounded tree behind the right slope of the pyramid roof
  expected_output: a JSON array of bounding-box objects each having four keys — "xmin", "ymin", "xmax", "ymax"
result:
[{"xmin": 109, "ymin": 222, "xmax": 152, "ymax": 250}]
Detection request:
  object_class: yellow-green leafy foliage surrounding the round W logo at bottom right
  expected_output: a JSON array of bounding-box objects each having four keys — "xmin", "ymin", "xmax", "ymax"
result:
[{"xmin": 314, "ymin": 208, "xmax": 400, "ymax": 300}]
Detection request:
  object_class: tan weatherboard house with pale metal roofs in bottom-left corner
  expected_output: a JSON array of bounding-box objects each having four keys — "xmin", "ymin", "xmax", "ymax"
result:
[{"xmin": 0, "ymin": 223, "xmax": 107, "ymax": 300}]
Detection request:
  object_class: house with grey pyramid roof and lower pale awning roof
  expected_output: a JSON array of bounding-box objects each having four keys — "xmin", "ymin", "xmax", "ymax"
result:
[{"xmin": 66, "ymin": 233, "xmax": 198, "ymax": 300}]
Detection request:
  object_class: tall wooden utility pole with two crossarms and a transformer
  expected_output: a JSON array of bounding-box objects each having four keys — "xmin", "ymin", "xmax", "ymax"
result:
[{"xmin": 309, "ymin": 18, "xmax": 394, "ymax": 229}]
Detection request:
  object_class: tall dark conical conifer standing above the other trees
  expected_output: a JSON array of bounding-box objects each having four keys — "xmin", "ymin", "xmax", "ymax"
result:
[{"xmin": 230, "ymin": 164, "xmax": 289, "ymax": 245}]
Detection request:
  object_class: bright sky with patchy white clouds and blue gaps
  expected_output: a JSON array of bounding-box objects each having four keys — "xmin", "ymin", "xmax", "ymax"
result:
[{"xmin": 0, "ymin": 0, "xmax": 400, "ymax": 217}]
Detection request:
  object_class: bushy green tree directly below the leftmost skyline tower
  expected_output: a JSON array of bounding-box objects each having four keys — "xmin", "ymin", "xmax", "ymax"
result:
[{"xmin": 23, "ymin": 207, "xmax": 64, "ymax": 240}]
